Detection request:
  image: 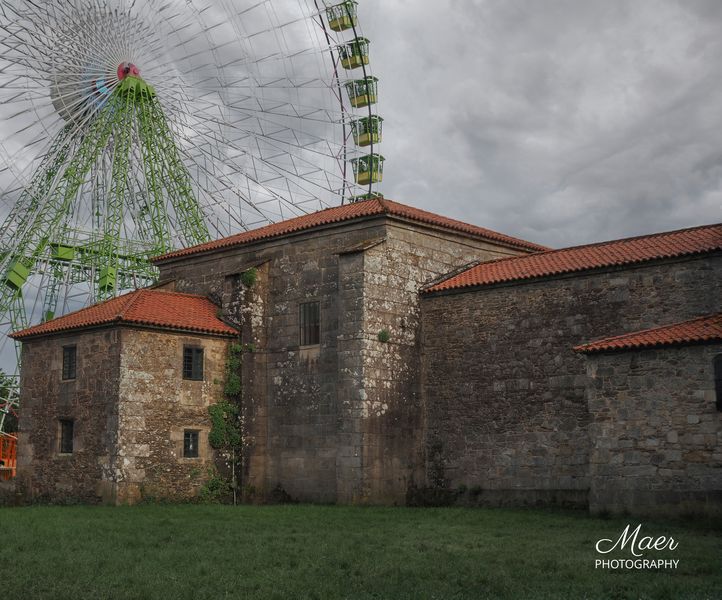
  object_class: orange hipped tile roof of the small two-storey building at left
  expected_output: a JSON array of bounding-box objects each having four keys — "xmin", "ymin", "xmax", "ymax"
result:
[{"xmin": 11, "ymin": 289, "xmax": 237, "ymax": 340}]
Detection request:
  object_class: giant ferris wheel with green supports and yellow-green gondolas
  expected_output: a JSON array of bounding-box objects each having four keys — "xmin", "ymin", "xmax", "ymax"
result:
[{"xmin": 0, "ymin": 0, "xmax": 384, "ymax": 430}]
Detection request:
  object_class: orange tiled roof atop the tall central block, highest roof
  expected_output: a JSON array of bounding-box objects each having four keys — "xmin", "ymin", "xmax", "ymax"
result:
[{"xmin": 153, "ymin": 198, "xmax": 548, "ymax": 262}]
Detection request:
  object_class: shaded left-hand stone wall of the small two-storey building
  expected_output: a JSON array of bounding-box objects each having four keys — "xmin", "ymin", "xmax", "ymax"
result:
[{"xmin": 17, "ymin": 329, "xmax": 120, "ymax": 503}]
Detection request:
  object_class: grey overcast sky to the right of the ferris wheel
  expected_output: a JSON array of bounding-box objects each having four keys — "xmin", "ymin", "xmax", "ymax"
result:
[{"xmin": 359, "ymin": 0, "xmax": 722, "ymax": 247}]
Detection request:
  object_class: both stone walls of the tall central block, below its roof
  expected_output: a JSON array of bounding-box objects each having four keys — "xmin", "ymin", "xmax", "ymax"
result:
[{"xmin": 155, "ymin": 218, "xmax": 524, "ymax": 502}]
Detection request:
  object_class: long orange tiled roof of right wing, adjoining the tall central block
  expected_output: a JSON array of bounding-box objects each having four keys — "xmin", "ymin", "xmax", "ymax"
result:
[{"xmin": 424, "ymin": 224, "xmax": 722, "ymax": 293}]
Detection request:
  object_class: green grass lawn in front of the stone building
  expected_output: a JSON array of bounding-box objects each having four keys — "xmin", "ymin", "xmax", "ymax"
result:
[{"xmin": 0, "ymin": 506, "xmax": 722, "ymax": 600}]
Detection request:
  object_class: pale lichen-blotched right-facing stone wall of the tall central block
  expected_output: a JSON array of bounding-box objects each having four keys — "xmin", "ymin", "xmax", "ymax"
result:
[{"xmin": 358, "ymin": 223, "xmax": 511, "ymax": 504}]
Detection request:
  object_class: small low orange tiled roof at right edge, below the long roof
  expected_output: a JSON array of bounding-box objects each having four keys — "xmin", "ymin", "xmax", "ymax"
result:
[{"xmin": 574, "ymin": 313, "xmax": 722, "ymax": 353}]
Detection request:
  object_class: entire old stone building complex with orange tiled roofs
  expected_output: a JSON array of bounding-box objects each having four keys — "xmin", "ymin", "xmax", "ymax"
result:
[{"xmin": 9, "ymin": 198, "xmax": 722, "ymax": 514}]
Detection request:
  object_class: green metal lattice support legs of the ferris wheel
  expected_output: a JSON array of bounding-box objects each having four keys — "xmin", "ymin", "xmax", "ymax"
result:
[{"xmin": 0, "ymin": 71, "xmax": 210, "ymax": 346}]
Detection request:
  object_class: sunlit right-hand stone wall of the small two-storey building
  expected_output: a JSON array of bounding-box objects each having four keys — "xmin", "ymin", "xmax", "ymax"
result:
[{"xmin": 113, "ymin": 328, "xmax": 229, "ymax": 504}]
